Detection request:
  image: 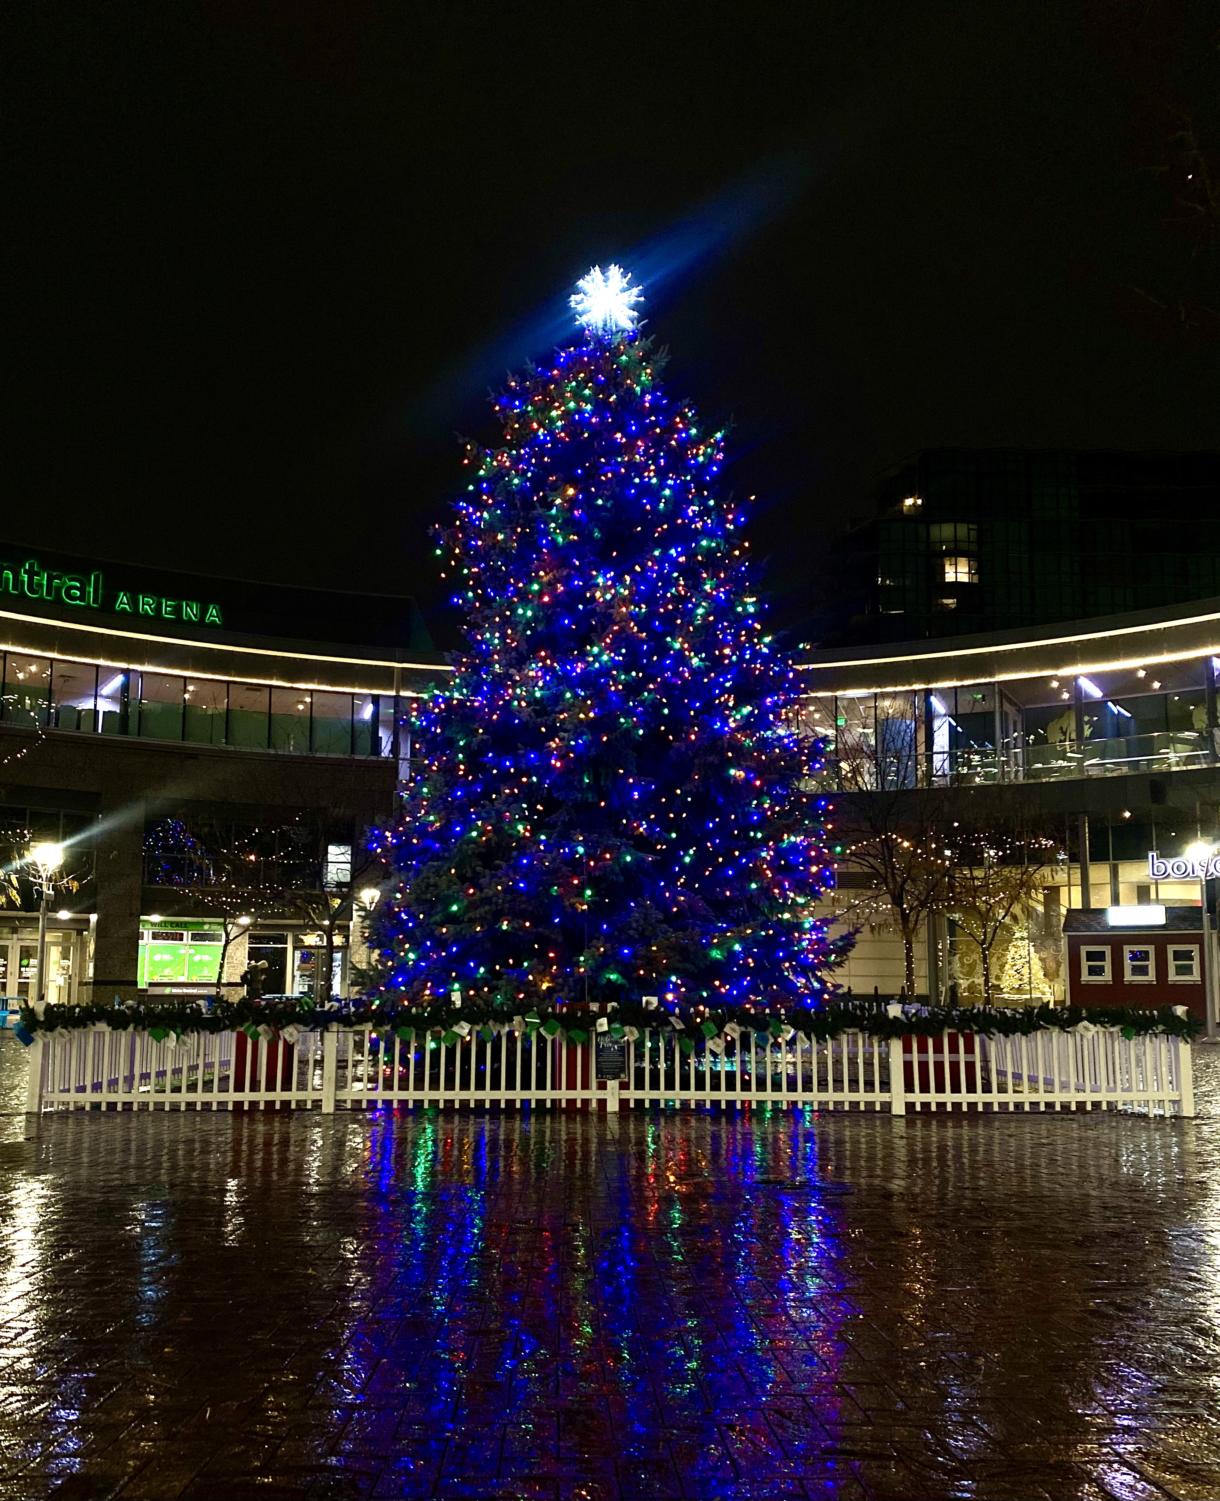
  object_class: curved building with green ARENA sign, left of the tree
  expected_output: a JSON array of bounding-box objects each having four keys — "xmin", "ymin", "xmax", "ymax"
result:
[{"xmin": 0, "ymin": 545, "xmax": 446, "ymax": 1000}]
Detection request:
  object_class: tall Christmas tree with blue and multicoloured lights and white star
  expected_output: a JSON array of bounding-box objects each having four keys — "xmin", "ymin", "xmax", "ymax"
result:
[{"xmin": 375, "ymin": 266, "xmax": 845, "ymax": 1009}]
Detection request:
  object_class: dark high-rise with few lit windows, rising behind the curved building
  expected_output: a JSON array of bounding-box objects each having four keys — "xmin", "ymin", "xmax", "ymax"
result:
[{"xmin": 840, "ymin": 449, "xmax": 1220, "ymax": 645}]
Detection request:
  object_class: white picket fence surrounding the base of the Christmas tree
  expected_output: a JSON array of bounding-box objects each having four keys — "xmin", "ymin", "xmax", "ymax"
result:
[{"xmin": 27, "ymin": 1027, "xmax": 1194, "ymax": 1115}]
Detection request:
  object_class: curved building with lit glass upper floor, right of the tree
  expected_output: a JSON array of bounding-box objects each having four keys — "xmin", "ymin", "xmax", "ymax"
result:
[{"xmin": 803, "ymin": 599, "xmax": 1220, "ymax": 1006}]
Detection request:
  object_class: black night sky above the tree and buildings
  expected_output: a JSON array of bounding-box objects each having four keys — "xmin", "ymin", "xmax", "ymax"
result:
[{"xmin": 9, "ymin": 0, "xmax": 1220, "ymax": 639}]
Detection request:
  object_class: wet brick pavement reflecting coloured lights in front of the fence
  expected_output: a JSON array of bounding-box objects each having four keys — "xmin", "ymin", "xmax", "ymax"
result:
[{"xmin": 0, "ymin": 1039, "xmax": 1220, "ymax": 1501}]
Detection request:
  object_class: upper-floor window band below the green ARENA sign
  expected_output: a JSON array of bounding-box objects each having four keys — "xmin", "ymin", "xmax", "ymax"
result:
[{"xmin": 0, "ymin": 651, "xmax": 405, "ymax": 757}]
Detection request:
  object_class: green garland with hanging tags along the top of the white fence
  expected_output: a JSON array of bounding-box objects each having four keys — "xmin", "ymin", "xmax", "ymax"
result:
[{"xmin": 15, "ymin": 998, "xmax": 1202, "ymax": 1052}]
